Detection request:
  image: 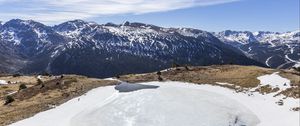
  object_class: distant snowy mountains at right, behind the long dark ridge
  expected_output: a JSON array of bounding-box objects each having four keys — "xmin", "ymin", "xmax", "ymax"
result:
[{"xmin": 214, "ymin": 30, "xmax": 300, "ymax": 68}]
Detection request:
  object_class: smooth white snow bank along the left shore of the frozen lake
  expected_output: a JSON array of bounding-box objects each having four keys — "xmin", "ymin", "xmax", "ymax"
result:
[{"xmin": 11, "ymin": 86, "xmax": 117, "ymax": 126}]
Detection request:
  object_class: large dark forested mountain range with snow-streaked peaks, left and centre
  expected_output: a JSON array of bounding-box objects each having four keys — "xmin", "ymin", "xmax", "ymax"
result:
[{"xmin": 0, "ymin": 19, "xmax": 263, "ymax": 77}]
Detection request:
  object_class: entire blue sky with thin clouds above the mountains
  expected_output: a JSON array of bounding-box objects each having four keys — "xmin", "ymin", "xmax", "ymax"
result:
[{"xmin": 0, "ymin": 0, "xmax": 300, "ymax": 32}]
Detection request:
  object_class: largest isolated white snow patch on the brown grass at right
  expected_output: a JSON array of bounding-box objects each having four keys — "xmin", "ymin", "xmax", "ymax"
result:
[{"xmin": 257, "ymin": 72, "xmax": 291, "ymax": 90}]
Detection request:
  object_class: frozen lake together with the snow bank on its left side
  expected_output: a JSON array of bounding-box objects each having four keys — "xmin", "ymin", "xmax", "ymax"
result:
[{"xmin": 13, "ymin": 82, "xmax": 260, "ymax": 126}]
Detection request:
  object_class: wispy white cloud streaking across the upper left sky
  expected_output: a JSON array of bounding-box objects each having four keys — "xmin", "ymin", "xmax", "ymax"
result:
[{"xmin": 0, "ymin": 0, "xmax": 238, "ymax": 23}]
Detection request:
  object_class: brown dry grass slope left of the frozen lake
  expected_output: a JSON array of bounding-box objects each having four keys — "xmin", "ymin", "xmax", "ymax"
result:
[{"xmin": 0, "ymin": 75, "xmax": 119, "ymax": 126}]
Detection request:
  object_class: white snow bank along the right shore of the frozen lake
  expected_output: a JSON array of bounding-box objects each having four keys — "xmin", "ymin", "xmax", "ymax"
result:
[{"xmin": 177, "ymin": 82, "xmax": 300, "ymax": 126}]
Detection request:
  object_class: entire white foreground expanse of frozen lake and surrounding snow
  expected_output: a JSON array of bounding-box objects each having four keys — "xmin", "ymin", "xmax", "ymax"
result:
[{"xmin": 11, "ymin": 73, "xmax": 299, "ymax": 126}]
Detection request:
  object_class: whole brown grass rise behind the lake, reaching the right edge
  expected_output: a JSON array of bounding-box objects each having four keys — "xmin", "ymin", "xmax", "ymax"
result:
[{"xmin": 120, "ymin": 65, "xmax": 300, "ymax": 98}]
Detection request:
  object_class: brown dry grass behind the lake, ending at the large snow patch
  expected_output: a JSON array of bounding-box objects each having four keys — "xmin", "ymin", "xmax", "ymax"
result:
[{"xmin": 120, "ymin": 65, "xmax": 274, "ymax": 88}]
